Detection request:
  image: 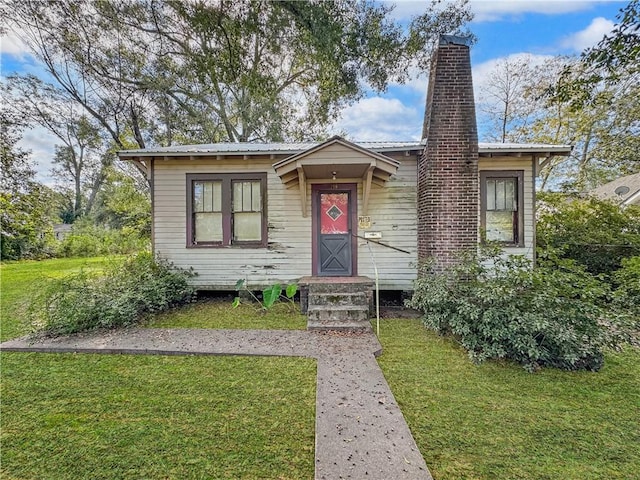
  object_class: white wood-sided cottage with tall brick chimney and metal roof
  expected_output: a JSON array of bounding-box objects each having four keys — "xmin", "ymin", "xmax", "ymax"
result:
[{"xmin": 119, "ymin": 37, "xmax": 571, "ymax": 290}]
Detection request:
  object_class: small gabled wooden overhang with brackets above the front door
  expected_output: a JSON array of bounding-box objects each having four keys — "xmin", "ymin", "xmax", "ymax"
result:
[{"xmin": 273, "ymin": 137, "xmax": 400, "ymax": 217}]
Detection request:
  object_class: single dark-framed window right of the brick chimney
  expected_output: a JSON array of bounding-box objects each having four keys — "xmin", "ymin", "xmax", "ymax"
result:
[{"xmin": 480, "ymin": 171, "xmax": 524, "ymax": 246}]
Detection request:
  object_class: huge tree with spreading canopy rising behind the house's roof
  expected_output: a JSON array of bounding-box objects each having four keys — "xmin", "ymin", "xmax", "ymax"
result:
[{"xmin": 4, "ymin": 0, "xmax": 470, "ymax": 148}]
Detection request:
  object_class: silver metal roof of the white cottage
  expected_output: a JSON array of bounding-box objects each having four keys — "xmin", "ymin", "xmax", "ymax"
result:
[{"xmin": 118, "ymin": 140, "xmax": 572, "ymax": 159}]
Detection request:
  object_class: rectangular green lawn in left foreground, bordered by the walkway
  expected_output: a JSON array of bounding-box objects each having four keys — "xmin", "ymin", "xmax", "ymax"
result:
[{"xmin": 0, "ymin": 353, "xmax": 315, "ymax": 479}]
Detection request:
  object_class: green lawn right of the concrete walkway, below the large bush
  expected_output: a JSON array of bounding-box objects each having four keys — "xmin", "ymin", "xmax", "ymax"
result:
[{"xmin": 379, "ymin": 320, "xmax": 640, "ymax": 480}]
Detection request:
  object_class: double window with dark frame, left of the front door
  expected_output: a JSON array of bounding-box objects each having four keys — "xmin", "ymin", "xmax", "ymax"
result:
[{"xmin": 187, "ymin": 173, "xmax": 267, "ymax": 247}]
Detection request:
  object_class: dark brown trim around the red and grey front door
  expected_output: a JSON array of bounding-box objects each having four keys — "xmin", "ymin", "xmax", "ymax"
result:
[{"xmin": 311, "ymin": 183, "xmax": 358, "ymax": 277}]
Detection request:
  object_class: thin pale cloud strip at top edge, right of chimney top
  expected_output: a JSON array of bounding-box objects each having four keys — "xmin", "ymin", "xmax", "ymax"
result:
[{"xmin": 471, "ymin": 0, "xmax": 597, "ymax": 22}]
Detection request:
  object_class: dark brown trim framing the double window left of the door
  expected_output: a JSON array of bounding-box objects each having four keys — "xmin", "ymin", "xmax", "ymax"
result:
[{"xmin": 186, "ymin": 173, "xmax": 268, "ymax": 248}]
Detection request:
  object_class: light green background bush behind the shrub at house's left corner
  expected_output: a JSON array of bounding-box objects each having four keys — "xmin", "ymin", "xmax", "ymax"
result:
[{"xmin": 58, "ymin": 223, "xmax": 149, "ymax": 257}]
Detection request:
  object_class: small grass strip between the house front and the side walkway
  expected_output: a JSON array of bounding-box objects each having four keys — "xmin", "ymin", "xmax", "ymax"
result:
[{"xmin": 146, "ymin": 297, "xmax": 307, "ymax": 330}]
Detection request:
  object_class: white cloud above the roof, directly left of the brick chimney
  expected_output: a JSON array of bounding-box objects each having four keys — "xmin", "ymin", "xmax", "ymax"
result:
[{"xmin": 334, "ymin": 97, "xmax": 423, "ymax": 141}]
